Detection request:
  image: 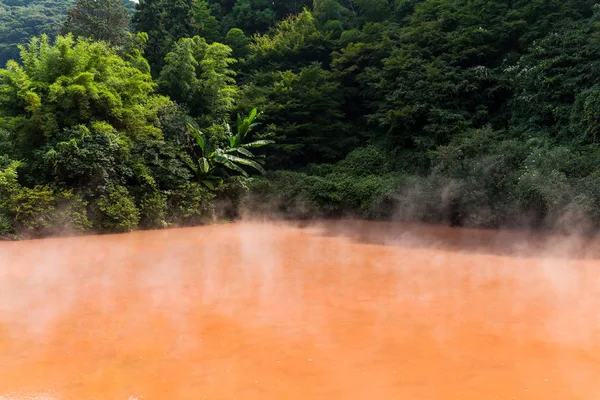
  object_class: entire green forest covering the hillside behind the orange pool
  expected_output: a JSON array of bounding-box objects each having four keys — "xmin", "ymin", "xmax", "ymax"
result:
[{"xmin": 0, "ymin": 0, "xmax": 600, "ymax": 239}]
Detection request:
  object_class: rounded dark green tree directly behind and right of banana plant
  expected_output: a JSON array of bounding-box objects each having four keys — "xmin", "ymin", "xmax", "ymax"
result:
[{"xmin": 242, "ymin": 63, "xmax": 352, "ymax": 169}]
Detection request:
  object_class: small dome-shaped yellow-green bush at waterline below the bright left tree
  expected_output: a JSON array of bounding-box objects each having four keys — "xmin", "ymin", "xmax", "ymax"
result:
[{"xmin": 97, "ymin": 185, "xmax": 140, "ymax": 232}]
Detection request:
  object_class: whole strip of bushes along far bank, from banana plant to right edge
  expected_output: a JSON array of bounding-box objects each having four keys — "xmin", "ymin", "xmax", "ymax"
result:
[{"xmin": 244, "ymin": 127, "xmax": 600, "ymax": 231}]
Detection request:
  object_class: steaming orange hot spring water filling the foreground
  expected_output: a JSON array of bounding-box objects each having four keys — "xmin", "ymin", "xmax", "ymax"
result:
[{"xmin": 0, "ymin": 222, "xmax": 600, "ymax": 400}]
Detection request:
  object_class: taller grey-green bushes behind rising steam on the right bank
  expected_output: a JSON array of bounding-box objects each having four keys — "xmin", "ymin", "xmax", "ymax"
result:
[{"xmin": 386, "ymin": 127, "xmax": 600, "ymax": 229}]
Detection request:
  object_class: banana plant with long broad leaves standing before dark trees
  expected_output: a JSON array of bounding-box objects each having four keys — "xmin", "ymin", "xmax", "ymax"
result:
[{"xmin": 188, "ymin": 108, "xmax": 274, "ymax": 190}]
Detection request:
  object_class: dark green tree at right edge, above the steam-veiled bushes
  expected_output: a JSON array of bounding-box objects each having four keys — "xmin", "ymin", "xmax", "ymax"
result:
[{"xmin": 505, "ymin": 10, "xmax": 600, "ymax": 142}]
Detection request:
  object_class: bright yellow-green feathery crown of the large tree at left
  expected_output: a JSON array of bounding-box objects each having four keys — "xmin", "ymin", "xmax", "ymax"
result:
[{"xmin": 0, "ymin": 36, "xmax": 169, "ymax": 150}]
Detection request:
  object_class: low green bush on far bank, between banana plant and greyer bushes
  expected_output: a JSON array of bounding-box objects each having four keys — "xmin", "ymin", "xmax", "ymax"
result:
[{"xmin": 244, "ymin": 152, "xmax": 404, "ymax": 219}]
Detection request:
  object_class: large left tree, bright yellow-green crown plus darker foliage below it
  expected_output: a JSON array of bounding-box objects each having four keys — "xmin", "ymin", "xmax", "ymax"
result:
[{"xmin": 0, "ymin": 36, "xmax": 178, "ymax": 229}]
